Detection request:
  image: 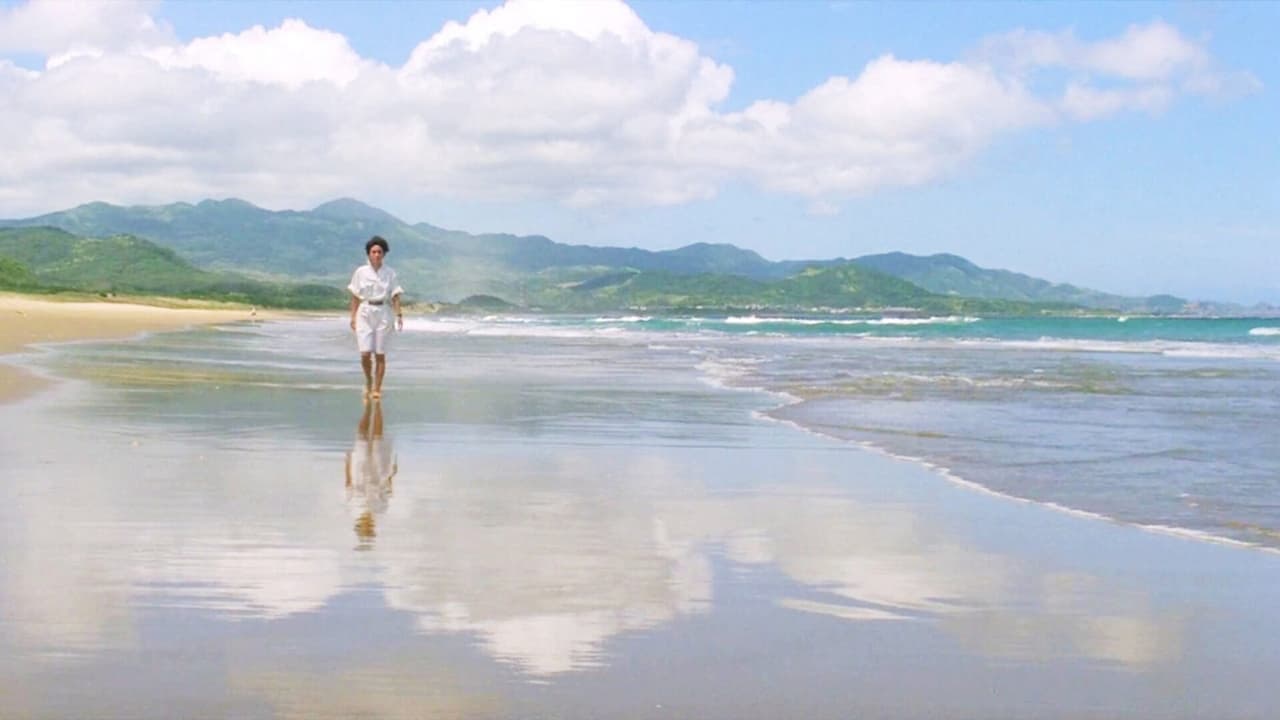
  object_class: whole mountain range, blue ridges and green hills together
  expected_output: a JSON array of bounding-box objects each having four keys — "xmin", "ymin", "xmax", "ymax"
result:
[{"xmin": 0, "ymin": 199, "xmax": 1218, "ymax": 313}]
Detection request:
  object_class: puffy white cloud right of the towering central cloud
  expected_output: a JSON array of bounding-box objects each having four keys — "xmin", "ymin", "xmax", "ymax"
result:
[{"xmin": 686, "ymin": 56, "xmax": 1052, "ymax": 197}]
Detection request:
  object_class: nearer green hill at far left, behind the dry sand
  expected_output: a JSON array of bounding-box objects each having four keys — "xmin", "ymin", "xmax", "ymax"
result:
[{"xmin": 0, "ymin": 227, "xmax": 346, "ymax": 303}]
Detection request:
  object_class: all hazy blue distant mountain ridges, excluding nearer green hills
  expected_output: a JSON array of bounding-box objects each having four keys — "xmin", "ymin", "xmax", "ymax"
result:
[{"xmin": 0, "ymin": 199, "xmax": 1185, "ymax": 313}]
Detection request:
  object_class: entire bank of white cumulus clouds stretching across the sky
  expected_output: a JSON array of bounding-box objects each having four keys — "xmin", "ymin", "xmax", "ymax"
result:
[{"xmin": 0, "ymin": 0, "xmax": 1257, "ymax": 215}]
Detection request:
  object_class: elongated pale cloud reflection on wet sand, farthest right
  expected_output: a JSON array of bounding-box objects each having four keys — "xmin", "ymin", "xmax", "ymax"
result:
[{"xmin": 711, "ymin": 493, "xmax": 1188, "ymax": 669}]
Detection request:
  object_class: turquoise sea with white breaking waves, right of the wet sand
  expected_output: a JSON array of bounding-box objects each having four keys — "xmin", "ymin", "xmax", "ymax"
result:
[{"xmin": 421, "ymin": 315, "xmax": 1280, "ymax": 550}]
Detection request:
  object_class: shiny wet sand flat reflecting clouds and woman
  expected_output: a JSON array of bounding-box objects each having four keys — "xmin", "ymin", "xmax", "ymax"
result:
[{"xmin": 0, "ymin": 315, "xmax": 1280, "ymax": 720}]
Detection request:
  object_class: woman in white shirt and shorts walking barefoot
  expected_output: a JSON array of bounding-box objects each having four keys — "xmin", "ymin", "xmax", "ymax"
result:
[{"xmin": 347, "ymin": 234, "xmax": 404, "ymax": 400}]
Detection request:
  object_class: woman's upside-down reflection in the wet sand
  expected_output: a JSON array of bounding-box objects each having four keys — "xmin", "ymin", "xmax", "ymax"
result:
[{"xmin": 344, "ymin": 400, "xmax": 398, "ymax": 550}]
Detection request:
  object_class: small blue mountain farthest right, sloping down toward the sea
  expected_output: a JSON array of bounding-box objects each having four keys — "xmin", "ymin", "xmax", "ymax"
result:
[{"xmin": 854, "ymin": 252, "xmax": 1187, "ymax": 313}]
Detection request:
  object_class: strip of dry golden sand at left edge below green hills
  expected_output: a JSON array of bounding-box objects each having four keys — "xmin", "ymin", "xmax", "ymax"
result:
[{"xmin": 0, "ymin": 293, "xmax": 261, "ymax": 402}]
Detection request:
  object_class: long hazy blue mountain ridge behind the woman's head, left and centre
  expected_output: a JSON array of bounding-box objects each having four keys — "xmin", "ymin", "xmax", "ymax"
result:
[{"xmin": 0, "ymin": 199, "xmax": 819, "ymax": 299}]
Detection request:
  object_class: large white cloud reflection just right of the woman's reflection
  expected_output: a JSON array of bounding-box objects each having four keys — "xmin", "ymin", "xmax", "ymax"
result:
[{"xmin": 379, "ymin": 450, "xmax": 712, "ymax": 675}]
